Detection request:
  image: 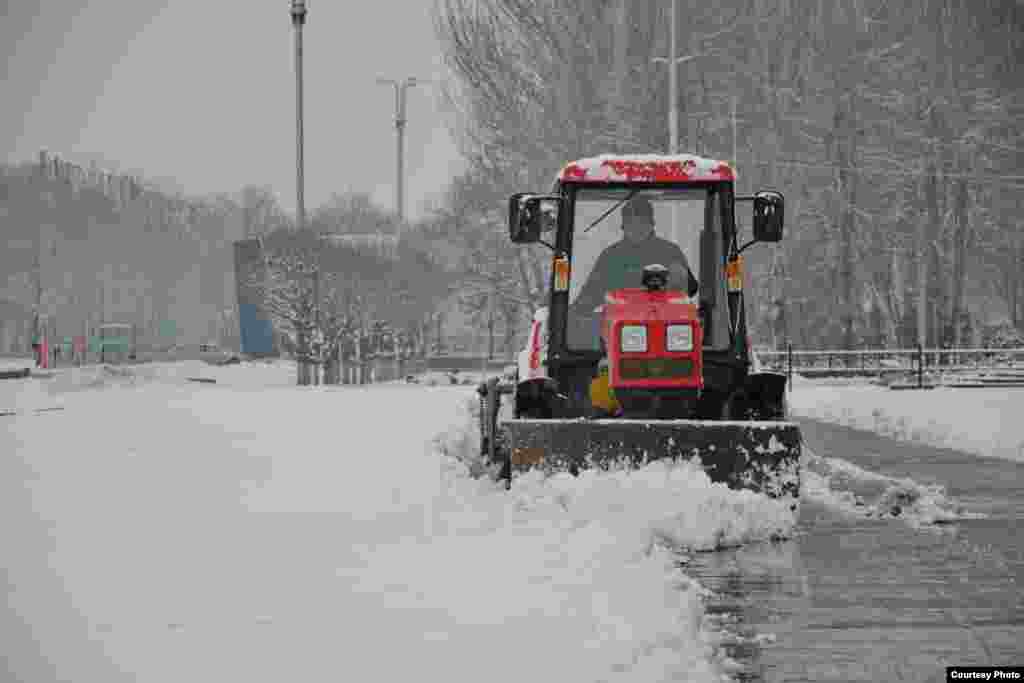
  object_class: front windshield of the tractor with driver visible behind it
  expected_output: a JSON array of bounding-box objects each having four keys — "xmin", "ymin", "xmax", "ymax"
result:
[{"xmin": 566, "ymin": 187, "xmax": 728, "ymax": 350}]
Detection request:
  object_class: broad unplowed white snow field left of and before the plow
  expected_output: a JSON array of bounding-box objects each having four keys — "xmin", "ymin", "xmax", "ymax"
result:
[{"xmin": 0, "ymin": 364, "xmax": 796, "ymax": 683}]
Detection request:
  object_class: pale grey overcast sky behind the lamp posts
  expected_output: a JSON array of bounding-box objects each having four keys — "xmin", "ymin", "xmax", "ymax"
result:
[{"xmin": 0, "ymin": 0, "xmax": 461, "ymax": 217}]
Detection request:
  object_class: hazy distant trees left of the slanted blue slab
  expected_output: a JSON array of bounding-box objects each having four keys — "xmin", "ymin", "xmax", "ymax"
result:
[{"xmin": 0, "ymin": 160, "xmax": 240, "ymax": 348}]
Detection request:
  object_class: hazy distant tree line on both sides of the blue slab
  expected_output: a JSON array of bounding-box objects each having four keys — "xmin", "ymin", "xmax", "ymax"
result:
[{"xmin": 0, "ymin": 155, "xmax": 464, "ymax": 374}]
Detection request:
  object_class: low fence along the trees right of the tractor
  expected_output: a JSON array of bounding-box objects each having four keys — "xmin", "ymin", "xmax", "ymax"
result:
[{"xmin": 756, "ymin": 345, "xmax": 1024, "ymax": 387}]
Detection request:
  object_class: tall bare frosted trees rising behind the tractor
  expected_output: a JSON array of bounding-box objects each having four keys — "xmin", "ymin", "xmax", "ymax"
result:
[{"xmin": 435, "ymin": 0, "xmax": 1024, "ymax": 347}]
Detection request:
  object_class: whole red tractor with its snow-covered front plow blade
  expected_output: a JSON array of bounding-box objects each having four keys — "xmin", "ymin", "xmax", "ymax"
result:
[{"xmin": 479, "ymin": 155, "xmax": 802, "ymax": 503}]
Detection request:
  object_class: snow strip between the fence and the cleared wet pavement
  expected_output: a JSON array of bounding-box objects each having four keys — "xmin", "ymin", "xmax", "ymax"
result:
[{"xmin": 788, "ymin": 380, "xmax": 1024, "ymax": 462}]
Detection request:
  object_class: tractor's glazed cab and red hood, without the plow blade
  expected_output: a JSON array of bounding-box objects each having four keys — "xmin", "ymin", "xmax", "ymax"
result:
[{"xmin": 509, "ymin": 155, "xmax": 783, "ymax": 419}]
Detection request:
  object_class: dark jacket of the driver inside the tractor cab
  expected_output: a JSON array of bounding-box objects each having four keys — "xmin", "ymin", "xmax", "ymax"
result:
[{"xmin": 573, "ymin": 233, "xmax": 697, "ymax": 311}]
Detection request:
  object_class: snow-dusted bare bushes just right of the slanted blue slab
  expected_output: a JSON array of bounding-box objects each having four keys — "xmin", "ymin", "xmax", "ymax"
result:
[{"xmin": 250, "ymin": 224, "xmax": 450, "ymax": 384}]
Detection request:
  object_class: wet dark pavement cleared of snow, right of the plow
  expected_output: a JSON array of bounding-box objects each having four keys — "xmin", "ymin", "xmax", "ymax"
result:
[{"xmin": 685, "ymin": 420, "xmax": 1024, "ymax": 683}]
